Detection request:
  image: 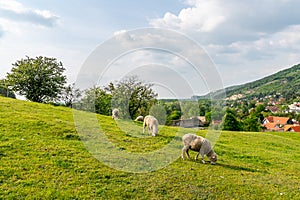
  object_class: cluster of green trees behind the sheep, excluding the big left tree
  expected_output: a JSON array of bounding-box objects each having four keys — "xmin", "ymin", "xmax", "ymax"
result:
[{"xmin": 73, "ymin": 76, "xmax": 158, "ymax": 118}]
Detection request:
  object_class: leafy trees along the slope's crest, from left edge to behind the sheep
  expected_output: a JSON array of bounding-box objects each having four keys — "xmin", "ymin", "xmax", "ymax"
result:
[{"xmin": 0, "ymin": 56, "xmax": 157, "ymax": 119}]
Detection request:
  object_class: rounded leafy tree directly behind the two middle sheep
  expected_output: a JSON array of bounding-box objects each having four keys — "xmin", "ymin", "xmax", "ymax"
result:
[{"xmin": 110, "ymin": 76, "xmax": 157, "ymax": 119}]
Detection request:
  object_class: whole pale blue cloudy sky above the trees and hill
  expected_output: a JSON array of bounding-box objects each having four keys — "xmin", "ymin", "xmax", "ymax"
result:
[{"xmin": 0, "ymin": 0, "xmax": 300, "ymax": 97}]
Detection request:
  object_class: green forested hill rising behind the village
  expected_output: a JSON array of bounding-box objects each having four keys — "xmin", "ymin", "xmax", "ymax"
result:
[{"xmin": 207, "ymin": 64, "xmax": 300, "ymax": 100}]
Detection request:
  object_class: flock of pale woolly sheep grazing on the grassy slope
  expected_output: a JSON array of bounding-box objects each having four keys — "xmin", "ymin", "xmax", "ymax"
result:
[{"xmin": 112, "ymin": 109, "xmax": 218, "ymax": 165}]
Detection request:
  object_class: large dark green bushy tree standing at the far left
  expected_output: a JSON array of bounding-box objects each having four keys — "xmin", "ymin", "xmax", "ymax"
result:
[{"xmin": 6, "ymin": 56, "xmax": 66, "ymax": 103}]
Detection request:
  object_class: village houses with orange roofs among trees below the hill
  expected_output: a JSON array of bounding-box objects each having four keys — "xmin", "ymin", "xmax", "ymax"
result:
[{"xmin": 170, "ymin": 94, "xmax": 300, "ymax": 132}]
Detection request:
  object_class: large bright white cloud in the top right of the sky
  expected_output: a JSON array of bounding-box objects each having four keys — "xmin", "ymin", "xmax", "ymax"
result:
[{"xmin": 149, "ymin": 0, "xmax": 300, "ymax": 44}]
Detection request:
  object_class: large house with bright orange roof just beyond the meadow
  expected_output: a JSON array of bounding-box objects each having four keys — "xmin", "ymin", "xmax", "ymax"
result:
[{"xmin": 263, "ymin": 116, "xmax": 293, "ymax": 131}]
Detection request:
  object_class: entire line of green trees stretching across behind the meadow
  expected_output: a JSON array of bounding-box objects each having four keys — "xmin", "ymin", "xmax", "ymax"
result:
[{"xmin": 0, "ymin": 56, "xmax": 300, "ymax": 131}]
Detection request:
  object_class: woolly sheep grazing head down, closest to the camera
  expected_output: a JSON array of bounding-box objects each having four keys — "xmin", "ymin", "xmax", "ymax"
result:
[{"xmin": 181, "ymin": 133, "xmax": 218, "ymax": 165}]
